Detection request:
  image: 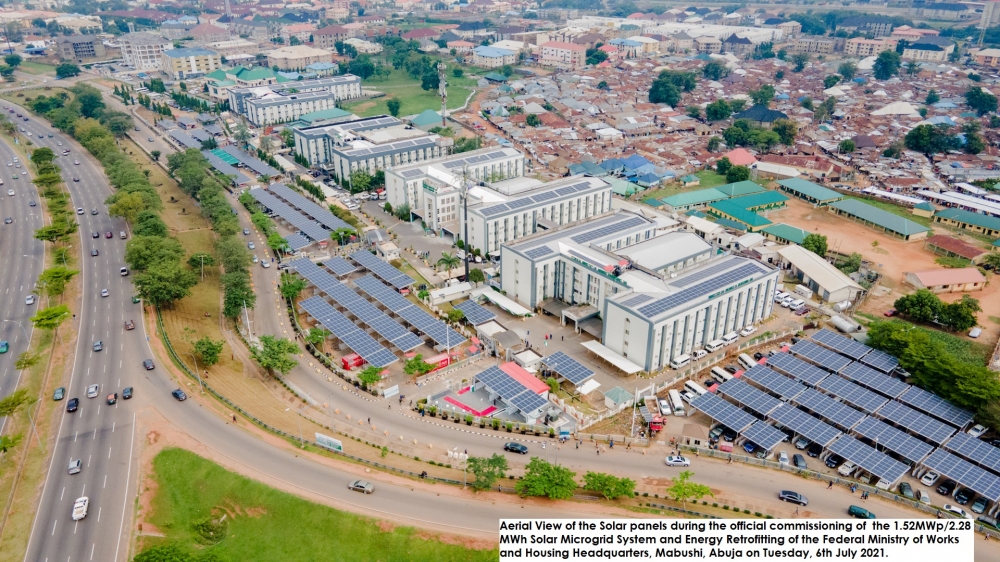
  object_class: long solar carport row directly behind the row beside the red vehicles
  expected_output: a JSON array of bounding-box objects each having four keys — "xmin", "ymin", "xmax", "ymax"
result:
[{"xmin": 288, "ymin": 258, "xmax": 424, "ymax": 352}]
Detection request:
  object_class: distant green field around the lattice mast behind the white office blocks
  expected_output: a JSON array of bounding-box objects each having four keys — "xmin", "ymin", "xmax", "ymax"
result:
[{"xmin": 343, "ymin": 65, "xmax": 476, "ymax": 117}]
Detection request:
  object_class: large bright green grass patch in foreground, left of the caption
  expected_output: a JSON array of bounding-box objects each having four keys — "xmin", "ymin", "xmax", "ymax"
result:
[{"xmin": 137, "ymin": 449, "xmax": 498, "ymax": 562}]
